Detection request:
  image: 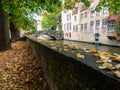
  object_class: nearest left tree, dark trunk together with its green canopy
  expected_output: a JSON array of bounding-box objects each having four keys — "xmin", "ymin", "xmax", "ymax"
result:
[{"xmin": 0, "ymin": 0, "xmax": 61, "ymax": 51}]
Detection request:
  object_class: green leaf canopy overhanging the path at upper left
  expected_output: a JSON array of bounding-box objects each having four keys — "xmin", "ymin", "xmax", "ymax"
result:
[{"xmin": 0, "ymin": 0, "xmax": 61, "ymax": 31}]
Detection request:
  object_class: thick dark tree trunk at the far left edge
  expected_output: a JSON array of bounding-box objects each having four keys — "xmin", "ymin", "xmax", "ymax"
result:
[{"xmin": 0, "ymin": 3, "xmax": 11, "ymax": 51}]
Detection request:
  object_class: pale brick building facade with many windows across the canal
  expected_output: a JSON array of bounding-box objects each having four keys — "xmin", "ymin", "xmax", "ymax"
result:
[{"xmin": 62, "ymin": 0, "xmax": 119, "ymax": 45}]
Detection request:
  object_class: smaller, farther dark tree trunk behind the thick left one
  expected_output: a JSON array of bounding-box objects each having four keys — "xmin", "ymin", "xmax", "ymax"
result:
[{"xmin": 10, "ymin": 21, "xmax": 20, "ymax": 41}]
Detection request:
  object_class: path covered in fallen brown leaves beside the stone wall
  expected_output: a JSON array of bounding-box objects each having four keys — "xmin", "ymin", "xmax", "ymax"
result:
[{"xmin": 0, "ymin": 41, "xmax": 49, "ymax": 90}]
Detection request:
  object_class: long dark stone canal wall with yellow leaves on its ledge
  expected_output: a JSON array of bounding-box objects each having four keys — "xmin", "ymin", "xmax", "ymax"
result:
[{"xmin": 27, "ymin": 35, "xmax": 120, "ymax": 90}]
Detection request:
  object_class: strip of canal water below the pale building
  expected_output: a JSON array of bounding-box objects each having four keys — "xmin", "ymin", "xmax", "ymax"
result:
[{"xmin": 63, "ymin": 40, "xmax": 120, "ymax": 54}]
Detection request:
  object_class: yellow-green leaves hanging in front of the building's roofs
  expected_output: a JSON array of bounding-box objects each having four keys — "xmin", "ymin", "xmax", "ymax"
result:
[{"xmin": 64, "ymin": 0, "xmax": 120, "ymax": 14}]
